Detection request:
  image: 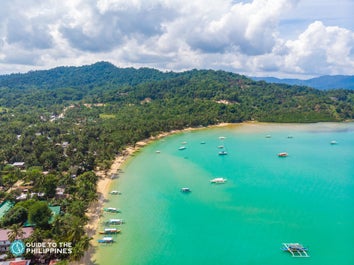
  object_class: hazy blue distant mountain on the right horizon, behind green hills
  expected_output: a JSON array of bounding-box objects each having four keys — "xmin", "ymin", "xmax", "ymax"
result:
[{"xmin": 251, "ymin": 75, "xmax": 354, "ymax": 90}]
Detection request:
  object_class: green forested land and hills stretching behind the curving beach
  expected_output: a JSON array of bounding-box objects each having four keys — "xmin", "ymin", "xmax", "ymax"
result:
[{"xmin": 0, "ymin": 62, "xmax": 354, "ymax": 259}]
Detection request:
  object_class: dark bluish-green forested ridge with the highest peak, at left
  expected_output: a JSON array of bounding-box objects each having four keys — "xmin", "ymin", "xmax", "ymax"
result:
[{"xmin": 0, "ymin": 62, "xmax": 173, "ymax": 89}]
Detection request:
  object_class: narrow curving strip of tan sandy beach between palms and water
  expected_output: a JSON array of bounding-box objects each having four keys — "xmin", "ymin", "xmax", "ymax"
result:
[{"xmin": 77, "ymin": 123, "xmax": 234, "ymax": 265}]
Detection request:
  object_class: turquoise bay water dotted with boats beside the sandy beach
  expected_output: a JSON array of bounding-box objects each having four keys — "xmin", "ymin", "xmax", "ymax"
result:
[{"xmin": 95, "ymin": 123, "xmax": 354, "ymax": 265}]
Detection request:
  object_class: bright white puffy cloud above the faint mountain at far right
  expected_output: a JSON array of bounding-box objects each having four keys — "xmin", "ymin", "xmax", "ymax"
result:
[{"xmin": 285, "ymin": 21, "xmax": 354, "ymax": 74}]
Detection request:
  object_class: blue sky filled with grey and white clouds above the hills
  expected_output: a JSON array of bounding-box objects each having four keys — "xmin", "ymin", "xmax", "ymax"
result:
[{"xmin": 0, "ymin": 0, "xmax": 354, "ymax": 79}]
